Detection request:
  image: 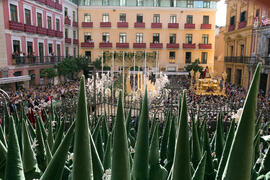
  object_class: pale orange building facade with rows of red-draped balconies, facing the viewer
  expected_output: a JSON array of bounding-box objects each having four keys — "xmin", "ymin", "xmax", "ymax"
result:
[{"xmin": 78, "ymin": 0, "xmax": 216, "ymax": 71}]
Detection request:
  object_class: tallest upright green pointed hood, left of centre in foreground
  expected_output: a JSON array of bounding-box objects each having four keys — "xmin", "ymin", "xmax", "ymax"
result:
[{"xmin": 72, "ymin": 76, "xmax": 94, "ymax": 180}]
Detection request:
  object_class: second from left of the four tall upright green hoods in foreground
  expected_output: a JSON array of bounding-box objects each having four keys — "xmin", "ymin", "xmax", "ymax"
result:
[{"xmin": 111, "ymin": 92, "xmax": 130, "ymax": 180}]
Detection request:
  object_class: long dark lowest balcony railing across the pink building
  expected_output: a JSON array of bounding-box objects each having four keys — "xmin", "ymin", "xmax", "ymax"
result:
[{"xmin": 12, "ymin": 55, "xmax": 64, "ymax": 66}]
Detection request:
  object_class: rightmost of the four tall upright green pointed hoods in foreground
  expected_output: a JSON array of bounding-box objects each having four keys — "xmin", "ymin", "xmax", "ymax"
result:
[{"xmin": 172, "ymin": 91, "xmax": 191, "ymax": 180}]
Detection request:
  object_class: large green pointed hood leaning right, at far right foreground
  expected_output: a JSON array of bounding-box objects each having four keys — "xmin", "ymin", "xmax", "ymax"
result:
[{"xmin": 222, "ymin": 63, "xmax": 262, "ymax": 180}]
